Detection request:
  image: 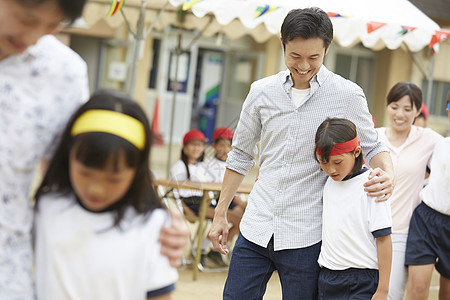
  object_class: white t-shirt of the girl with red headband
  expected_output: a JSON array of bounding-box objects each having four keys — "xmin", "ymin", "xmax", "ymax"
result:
[{"xmin": 318, "ymin": 171, "xmax": 392, "ymax": 270}]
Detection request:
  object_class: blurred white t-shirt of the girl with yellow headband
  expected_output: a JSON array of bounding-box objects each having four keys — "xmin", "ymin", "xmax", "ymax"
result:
[{"xmin": 35, "ymin": 194, "xmax": 178, "ymax": 300}]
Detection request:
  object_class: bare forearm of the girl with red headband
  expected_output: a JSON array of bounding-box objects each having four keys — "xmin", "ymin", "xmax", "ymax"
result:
[{"xmin": 372, "ymin": 234, "xmax": 392, "ymax": 299}]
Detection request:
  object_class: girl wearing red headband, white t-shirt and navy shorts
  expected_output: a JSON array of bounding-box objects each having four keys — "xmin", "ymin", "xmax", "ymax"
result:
[{"xmin": 314, "ymin": 118, "xmax": 392, "ymax": 299}]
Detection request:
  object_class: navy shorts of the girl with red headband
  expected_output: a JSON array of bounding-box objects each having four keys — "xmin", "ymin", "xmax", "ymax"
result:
[{"xmin": 319, "ymin": 268, "xmax": 378, "ymax": 300}]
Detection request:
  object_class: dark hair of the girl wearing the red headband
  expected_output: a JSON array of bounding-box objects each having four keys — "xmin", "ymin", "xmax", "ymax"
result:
[{"xmin": 314, "ymin": 118, "xmax": 364, "ymax": 173}]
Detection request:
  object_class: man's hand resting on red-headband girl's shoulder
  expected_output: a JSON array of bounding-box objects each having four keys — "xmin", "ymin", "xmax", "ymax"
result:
[{"xmin": 364, "ymin": 168, "xmax": 394, "ymax": 202}]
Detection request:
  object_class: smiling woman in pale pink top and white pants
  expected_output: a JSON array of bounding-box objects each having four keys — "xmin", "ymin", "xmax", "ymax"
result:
[{"xmin": 377, "ymin": 82, "xmax": 442, "ymax": 299}]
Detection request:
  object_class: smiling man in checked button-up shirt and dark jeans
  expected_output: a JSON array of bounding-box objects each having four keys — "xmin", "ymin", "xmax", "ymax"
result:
[{"xmin": 209, "ymin": 8, "xmax": 393, "ymax": 299}]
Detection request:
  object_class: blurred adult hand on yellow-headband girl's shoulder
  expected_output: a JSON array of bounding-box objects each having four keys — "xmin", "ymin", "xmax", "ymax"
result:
[{"xmin": 159, "ymin": 208, "xmax": 191, "ymax": 268}]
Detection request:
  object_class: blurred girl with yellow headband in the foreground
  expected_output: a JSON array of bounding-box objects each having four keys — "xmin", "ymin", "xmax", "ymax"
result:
[{"xmin": 35, "ymin": 91, "xmax": 178, "ymax": 300}]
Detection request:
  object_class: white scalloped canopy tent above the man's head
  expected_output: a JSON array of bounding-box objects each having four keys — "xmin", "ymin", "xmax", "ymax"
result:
[{"xmin": 169, "ymin": 0, "xmax": 439, "ymax": 52}]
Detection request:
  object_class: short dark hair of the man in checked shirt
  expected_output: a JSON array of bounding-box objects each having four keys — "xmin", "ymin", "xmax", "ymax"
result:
[{"xmin": 281, "ymin": 7, "xmax": 333, "ymax": 49}]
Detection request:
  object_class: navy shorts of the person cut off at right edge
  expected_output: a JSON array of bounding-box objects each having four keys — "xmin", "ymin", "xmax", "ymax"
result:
[{"xmin": 405, "ymin": 202, "xmax": 450, "ymax": 279}]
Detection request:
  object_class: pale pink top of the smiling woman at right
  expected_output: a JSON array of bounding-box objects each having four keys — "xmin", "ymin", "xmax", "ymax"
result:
[{"xmin": 376, "ymin": 125, "xmax": 443, "ymax": 234}]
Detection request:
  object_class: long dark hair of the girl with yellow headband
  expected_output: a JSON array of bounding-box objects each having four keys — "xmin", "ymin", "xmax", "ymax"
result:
[{"xmin": 35, "ymin": 90, "xmax": 162, "ymax": 226}]
